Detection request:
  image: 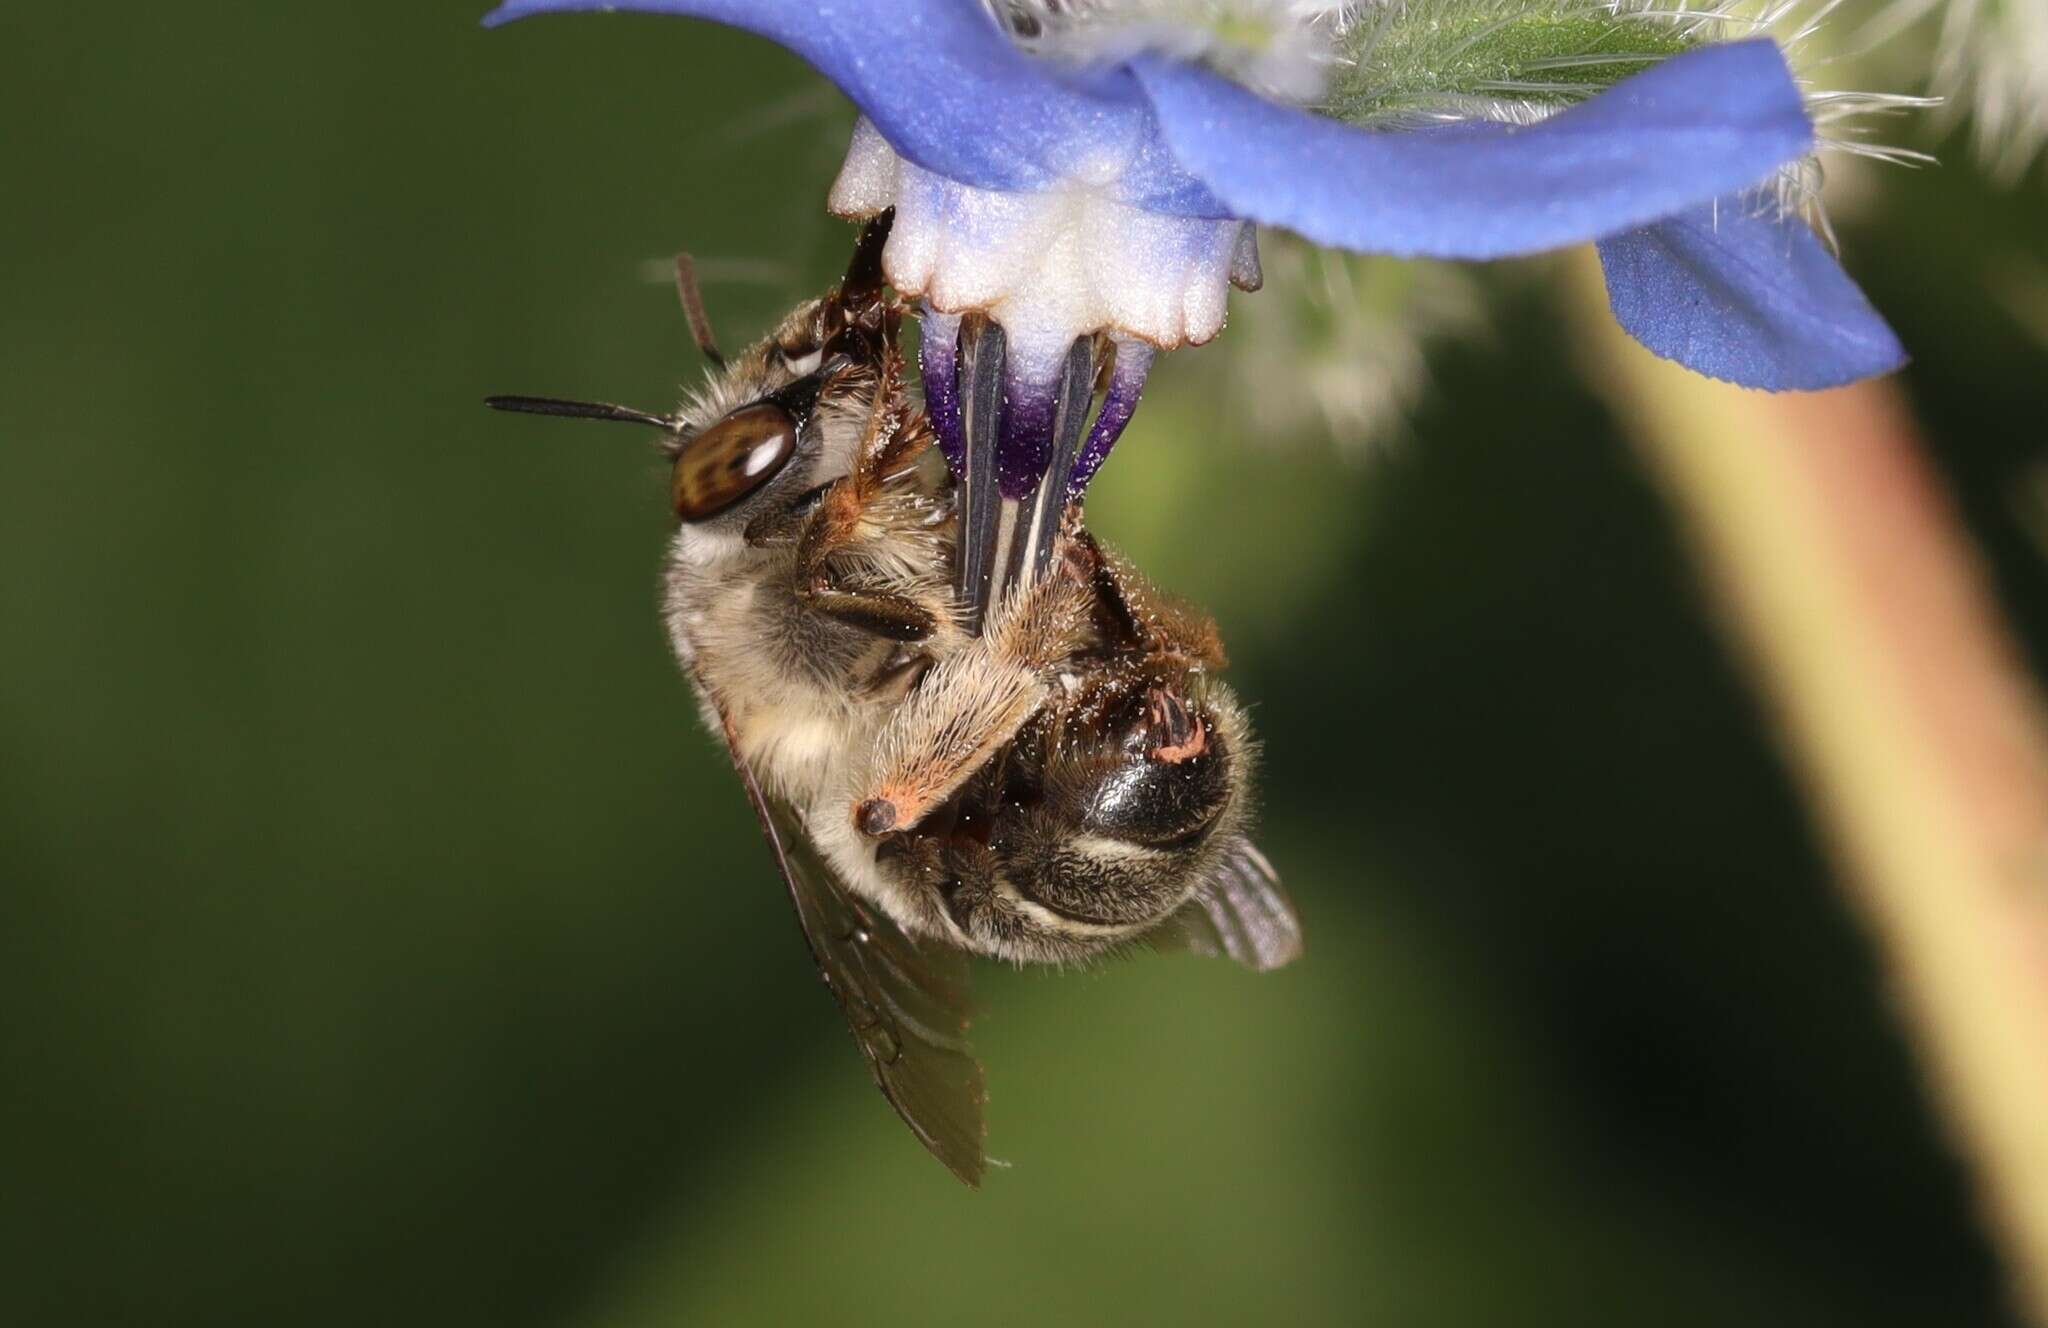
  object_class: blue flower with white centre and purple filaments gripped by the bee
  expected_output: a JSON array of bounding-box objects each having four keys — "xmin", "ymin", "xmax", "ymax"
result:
[{"xmin": 485, "ymin": 0, "xmax": 1905, "ymax": 498}]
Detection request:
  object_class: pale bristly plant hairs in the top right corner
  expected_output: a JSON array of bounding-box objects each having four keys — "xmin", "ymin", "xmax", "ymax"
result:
[{"xmin": 1864, "ymin": 0, "xmax": 2048, "ymax": 182}]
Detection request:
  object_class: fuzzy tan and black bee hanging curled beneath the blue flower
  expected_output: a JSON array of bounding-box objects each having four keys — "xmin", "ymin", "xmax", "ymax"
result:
[{"xmin": 487, "ymin": 215, "xmax": 1300, "ymax": 1185}]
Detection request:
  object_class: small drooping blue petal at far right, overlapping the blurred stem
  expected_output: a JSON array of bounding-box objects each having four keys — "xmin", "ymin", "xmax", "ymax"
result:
[{"xmin": 1599, "ymin": 197, "xmax": 1907, "ymax": 391}]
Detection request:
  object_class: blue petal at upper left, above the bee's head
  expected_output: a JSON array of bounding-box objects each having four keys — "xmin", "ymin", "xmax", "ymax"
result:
[{"xmin": 483, "ymin": 0, "xmax": 1155, "ymax": 194}]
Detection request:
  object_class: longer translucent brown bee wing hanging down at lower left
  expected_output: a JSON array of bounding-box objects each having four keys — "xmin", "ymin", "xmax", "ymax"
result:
[{"xmin": 727, "ymin": 717, "xmax": 987, "ymax": 1187}]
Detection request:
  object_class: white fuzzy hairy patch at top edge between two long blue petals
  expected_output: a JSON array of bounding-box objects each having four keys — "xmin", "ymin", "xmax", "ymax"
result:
[{"xmin": 985, "ymin": 0, "xmax": 1358, "ymax": 105}]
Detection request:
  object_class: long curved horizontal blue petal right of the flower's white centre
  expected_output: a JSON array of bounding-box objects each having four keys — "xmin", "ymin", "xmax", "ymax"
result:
[{"xmin": 1133, "ymin": 39, "xmax": 1812, "ymax": 258}]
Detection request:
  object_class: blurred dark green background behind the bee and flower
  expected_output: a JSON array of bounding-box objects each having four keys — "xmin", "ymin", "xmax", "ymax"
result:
[{"xmin": 0, "ymin": 0, "xmax": 2048, "ymax": 1328}]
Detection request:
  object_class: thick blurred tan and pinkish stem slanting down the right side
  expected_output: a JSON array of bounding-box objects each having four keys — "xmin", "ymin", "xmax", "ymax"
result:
[{"xmin": 1571, "ymin": 252, "xmax": 2048, "ymax": 1326}]
